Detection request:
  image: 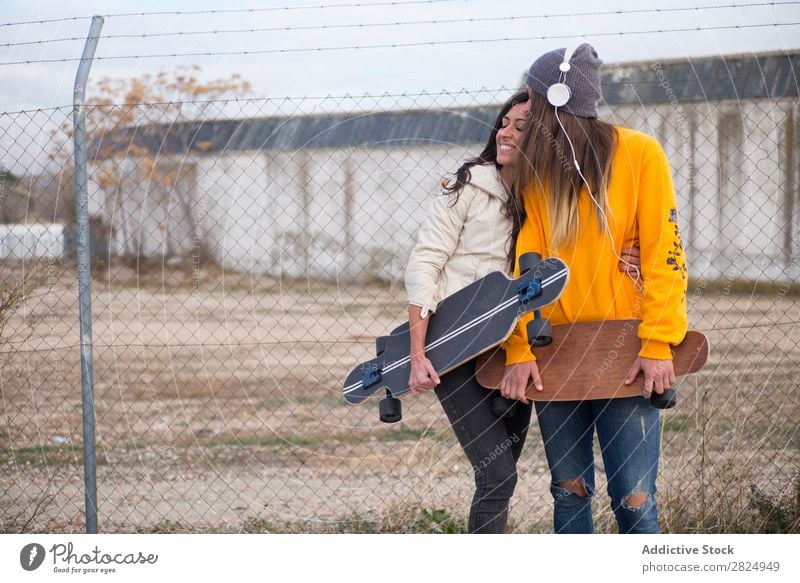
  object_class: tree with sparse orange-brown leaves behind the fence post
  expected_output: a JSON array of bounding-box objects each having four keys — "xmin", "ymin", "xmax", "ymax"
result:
[{"xmin": 51, "ymin": 65, "xmax": 250, "ymax": 260}]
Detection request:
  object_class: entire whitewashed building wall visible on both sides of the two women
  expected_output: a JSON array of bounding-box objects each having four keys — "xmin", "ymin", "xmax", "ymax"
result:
[{"xmin": 92, "ymin": 100, "xmax": 800, "ymax": 281}]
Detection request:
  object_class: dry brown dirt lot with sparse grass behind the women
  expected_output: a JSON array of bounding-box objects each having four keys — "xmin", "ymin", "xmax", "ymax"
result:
[{"xmin": 0, "ymin": 266, "xmax": 800, "ymax": 532}]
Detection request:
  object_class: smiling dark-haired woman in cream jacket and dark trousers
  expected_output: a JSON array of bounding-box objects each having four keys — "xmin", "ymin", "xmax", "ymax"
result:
[{"xmin": 406, "ymin": 93, "xmax": 531, "ymax": 533}]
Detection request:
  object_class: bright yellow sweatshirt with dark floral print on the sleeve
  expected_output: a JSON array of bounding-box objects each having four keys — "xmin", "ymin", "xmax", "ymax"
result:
[{"xmin": 504, "ymin": 127, "xmax": 687, "ymax": 364}]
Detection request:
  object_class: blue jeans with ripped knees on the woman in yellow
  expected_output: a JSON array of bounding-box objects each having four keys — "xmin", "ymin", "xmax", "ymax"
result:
[{"xmin": 536, "ymin": 397, "xmax": 661, "ymax": 534}]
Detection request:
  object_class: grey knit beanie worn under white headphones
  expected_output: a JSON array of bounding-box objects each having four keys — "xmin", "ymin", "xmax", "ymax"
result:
[{"xmin": 527, "ymin": 43, "xmax": 603, "ymax": 117}]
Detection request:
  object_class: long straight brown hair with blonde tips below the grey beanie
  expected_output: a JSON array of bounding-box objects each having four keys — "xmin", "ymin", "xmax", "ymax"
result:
[{"xmin": 507, "ymin": 92, "xmax": 617, "ymax": 265}]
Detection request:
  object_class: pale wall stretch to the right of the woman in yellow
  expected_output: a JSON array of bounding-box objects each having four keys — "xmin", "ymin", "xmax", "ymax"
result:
[{"xmin": 601, "ymin": 100, "xmax": 800, "ymax": 281}]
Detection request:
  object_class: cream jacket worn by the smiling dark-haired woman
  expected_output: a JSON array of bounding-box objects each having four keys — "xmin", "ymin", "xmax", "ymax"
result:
[{"xmin": 405, "ymin": 164, "xmax": 511, "ymax": 317}]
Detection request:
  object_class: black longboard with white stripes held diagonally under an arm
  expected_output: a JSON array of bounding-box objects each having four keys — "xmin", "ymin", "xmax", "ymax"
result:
[{"xmin": 343, "ymin": 258, "xmax": 569, "ymax": 405}]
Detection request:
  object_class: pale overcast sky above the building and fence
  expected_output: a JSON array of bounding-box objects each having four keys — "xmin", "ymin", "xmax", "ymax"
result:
[{"xmin": 0, "ymin": 0, "xmax": 800, "ymax": 111}]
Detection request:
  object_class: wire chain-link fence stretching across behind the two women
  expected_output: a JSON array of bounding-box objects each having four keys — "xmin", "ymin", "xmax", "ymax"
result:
[{"xmin": 0, "ymin": 57, "xmax": 800, "ymax": 532}]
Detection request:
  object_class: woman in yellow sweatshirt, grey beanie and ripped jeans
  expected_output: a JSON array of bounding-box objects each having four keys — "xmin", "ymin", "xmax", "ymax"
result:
[{"xmin": 501, "ymin": 44, "xmax": 687, "ymax": 533}]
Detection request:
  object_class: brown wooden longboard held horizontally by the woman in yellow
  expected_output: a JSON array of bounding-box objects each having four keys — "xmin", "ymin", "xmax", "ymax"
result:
[{"xmin": 475, "ymin": 320, "xmax": 708, "ymax": 401}]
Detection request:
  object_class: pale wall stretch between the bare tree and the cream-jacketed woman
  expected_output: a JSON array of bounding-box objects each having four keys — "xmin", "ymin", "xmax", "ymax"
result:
[{"xmin": 195, "ymin": 147, "xmax": 465, "ymax": 281}]
